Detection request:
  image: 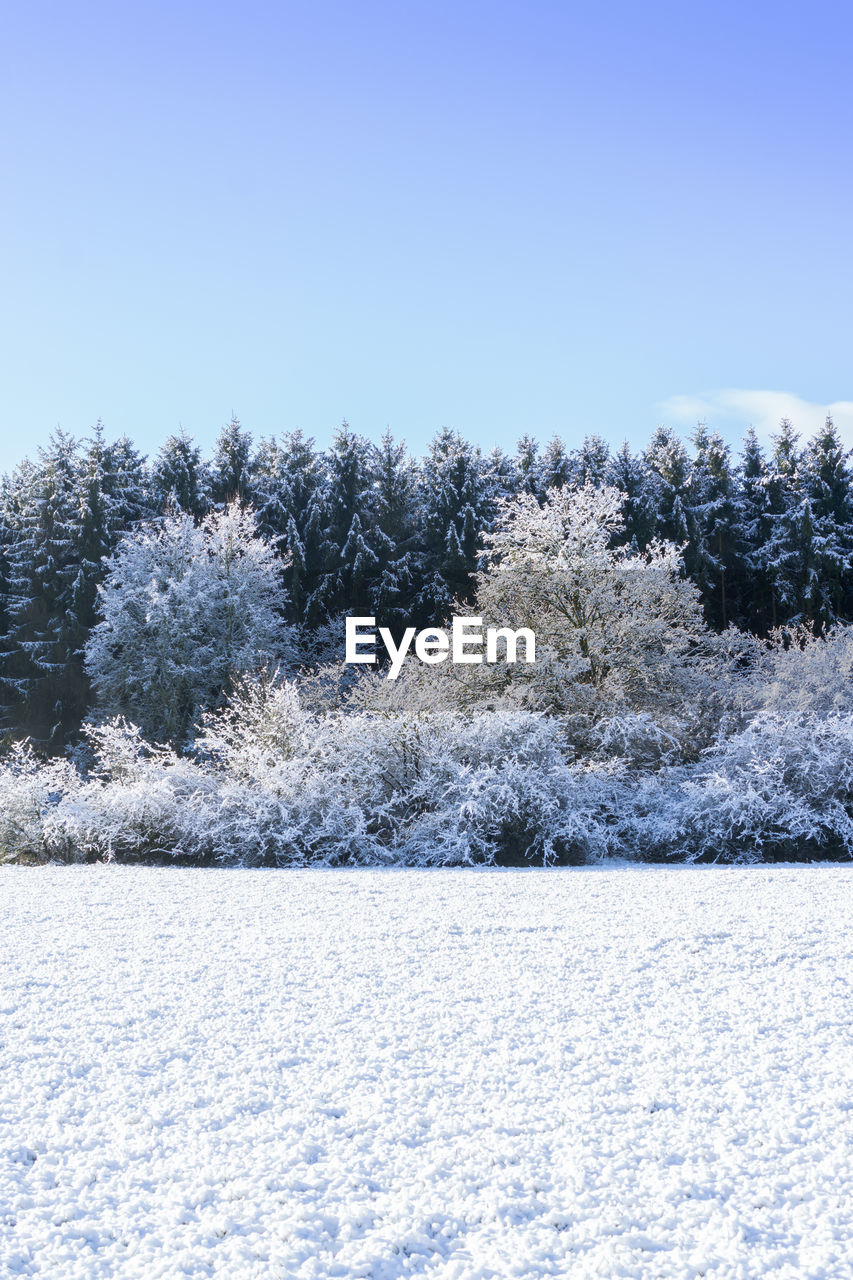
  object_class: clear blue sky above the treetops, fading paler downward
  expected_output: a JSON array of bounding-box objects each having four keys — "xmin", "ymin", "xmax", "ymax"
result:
[{"xmin": 0, "ymin": 0, "xmax": 853, "ymax": 468}]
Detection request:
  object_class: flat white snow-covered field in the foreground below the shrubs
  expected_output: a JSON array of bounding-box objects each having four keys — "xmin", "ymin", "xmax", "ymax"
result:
[{"xmin": 0, "ymin": 867, "xmax": 853, "ymax": 1280}]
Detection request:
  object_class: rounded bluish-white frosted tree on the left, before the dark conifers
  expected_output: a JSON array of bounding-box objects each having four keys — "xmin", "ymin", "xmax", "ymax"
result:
[{"xmin": 86, "ymin": 504, "xmax": 286, "ymax": 744}]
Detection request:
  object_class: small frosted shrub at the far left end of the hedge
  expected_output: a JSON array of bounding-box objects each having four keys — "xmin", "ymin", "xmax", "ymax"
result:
[{"xmin": 0, "ymin": 742, "xmax": 79, "ymax": 861}]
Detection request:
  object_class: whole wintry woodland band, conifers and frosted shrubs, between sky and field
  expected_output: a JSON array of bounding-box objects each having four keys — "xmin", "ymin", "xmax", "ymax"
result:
[{"xmin": 0, "ymin": 417, "xmax": 853, "ymax": 865}]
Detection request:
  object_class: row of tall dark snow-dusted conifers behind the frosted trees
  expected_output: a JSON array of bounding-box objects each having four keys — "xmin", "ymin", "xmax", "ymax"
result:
[{"xmin": 0, "ymin": 417, "xmax": 853, "ymax": 750}]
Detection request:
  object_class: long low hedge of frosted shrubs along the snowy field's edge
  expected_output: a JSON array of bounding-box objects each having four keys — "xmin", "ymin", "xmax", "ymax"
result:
[{"xmin": 8, "ymin": 629, "xmax": 853, "ymax": 865}]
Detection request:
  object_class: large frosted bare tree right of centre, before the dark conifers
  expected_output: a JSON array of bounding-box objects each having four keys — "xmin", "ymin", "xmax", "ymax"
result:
[{"xmin": 476, "ymin": 485, "xmax": 710, "ymax": 732}]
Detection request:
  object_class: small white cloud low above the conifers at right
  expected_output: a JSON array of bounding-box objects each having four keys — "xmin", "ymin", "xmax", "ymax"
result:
[{"xmin": 656, "ymin": 387, "xmax": 853, "ymax": 445}]
